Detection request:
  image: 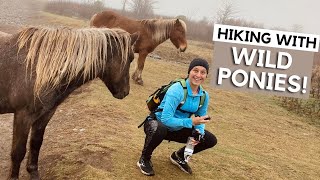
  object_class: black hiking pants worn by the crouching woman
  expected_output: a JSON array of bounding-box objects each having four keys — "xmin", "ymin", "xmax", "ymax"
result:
[{"xmin": 141, "ymin": 117, "xmax": 217, "ymax": 159}]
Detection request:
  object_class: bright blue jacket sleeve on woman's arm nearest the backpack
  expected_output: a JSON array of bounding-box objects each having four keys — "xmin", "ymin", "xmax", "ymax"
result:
[{"xmin": 161, "ymin": 84, "xmax": 192, "ymax": 128}]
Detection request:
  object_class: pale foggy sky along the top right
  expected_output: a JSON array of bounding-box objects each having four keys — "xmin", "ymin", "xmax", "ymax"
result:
[{"xmin": 105, "ymin": 0, "xmax": 320, "ymax": 35}]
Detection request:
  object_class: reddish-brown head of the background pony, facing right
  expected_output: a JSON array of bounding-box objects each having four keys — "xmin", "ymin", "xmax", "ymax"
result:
[{"xmin": 170, "ymin": 19, "xmax": 187, "ymax": 52}]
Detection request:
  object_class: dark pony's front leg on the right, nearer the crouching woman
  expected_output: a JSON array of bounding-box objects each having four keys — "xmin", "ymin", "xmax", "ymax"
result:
[{"xmin": 27, "ymin": 108, "xmax": 57, "ymax": 180}]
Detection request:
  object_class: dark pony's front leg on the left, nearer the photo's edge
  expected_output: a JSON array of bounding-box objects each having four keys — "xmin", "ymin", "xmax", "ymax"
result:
[{"xmin": 9, "ymin": 110, "xmax": 32, "ymax": 179}]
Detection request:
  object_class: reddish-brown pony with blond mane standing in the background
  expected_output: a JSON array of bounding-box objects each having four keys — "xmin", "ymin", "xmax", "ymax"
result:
[{"xmin": 90, "ymin": 11, "xmax": 187, "ymax": 85}]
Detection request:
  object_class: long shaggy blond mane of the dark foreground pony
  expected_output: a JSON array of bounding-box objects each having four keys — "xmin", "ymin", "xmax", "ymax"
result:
[{"xmin": 18, "ymin": 27, "xmax": 131, "ymax": 97}]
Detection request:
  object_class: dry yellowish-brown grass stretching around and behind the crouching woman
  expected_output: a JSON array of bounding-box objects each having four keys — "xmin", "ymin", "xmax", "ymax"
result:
[{"xmin": 45, "ymin": 59, "xmax": 320, "ymax": 179}]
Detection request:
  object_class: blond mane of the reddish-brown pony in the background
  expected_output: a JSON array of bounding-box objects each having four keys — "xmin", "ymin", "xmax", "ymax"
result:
[{"xmin": 141, "ymin": 19, "xmax": 187, "ymax": 43}]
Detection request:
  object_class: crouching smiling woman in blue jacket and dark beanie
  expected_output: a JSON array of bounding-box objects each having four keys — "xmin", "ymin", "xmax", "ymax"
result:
[{"xmin": 137, "ymin": 58, "xmax": 217, "ymax": 176}]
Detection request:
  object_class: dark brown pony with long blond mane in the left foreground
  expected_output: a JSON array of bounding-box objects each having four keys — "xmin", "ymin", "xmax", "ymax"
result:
[{"xmin": 0, "ymin": 27, "xmax": 138, "ymax": 179}]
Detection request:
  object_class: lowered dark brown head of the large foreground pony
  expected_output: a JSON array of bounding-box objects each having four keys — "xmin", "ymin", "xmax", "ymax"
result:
[{"xmin": 100, "ymin": 29, "xmax": 139, "ymax": 99}]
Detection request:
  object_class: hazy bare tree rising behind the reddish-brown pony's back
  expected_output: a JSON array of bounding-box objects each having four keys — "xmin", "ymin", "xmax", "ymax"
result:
[{"xmin": 129, "ymin": 0, "xmax": 157, "ymax": 19}]
